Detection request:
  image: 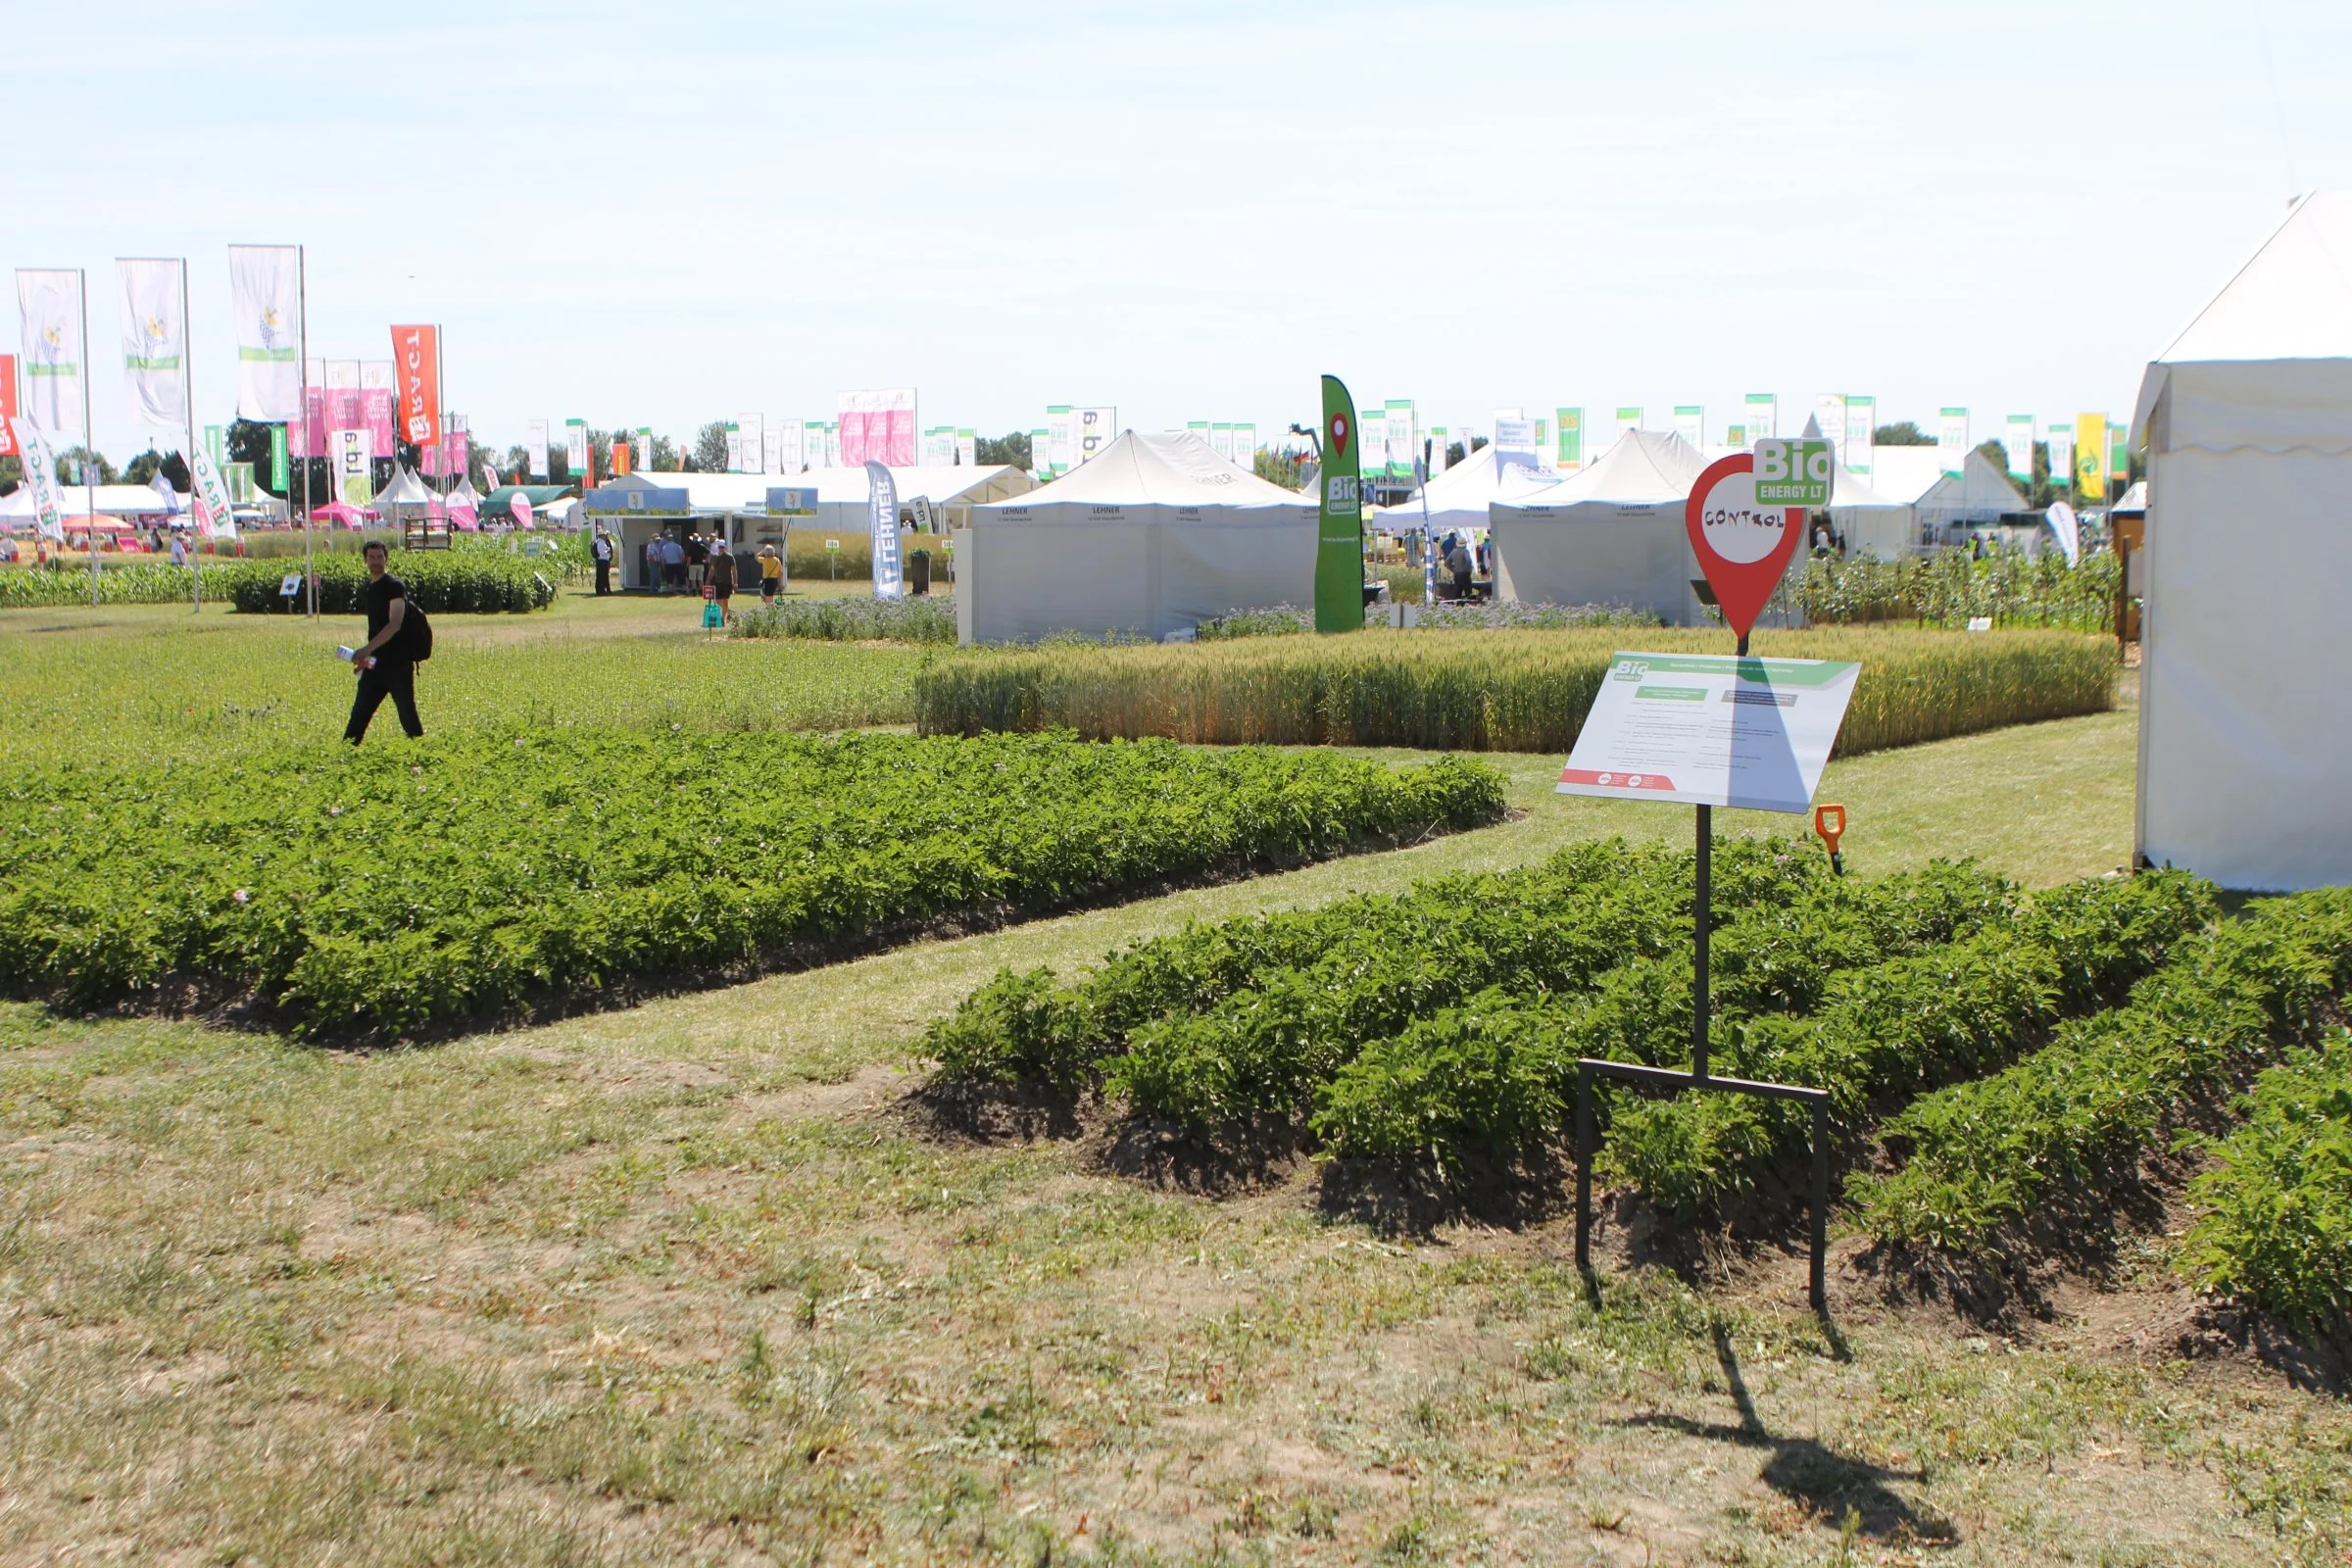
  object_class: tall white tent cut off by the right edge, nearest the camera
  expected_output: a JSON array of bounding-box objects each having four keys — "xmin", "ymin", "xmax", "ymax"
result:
[{"xmin": 2131, "ymin": 190, "xmax": 2352, "ymax": 891}]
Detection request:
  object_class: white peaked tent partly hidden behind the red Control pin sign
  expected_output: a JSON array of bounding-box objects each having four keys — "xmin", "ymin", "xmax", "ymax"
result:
[{"xmin": 1487, "ymin": 430, "xmax": 1801, "ymax": 625}]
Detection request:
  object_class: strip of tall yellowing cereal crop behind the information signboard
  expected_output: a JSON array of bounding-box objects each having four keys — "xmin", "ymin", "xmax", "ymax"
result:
[{"xmin": 915, "ymin": 627, "xmax": 2115, "ymax": 755}]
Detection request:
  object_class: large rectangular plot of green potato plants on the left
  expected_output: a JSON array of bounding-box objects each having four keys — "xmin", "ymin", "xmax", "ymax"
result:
[{"xmin": 0, "ymin": 729, "xmax": 1503, "ymax": 1034}]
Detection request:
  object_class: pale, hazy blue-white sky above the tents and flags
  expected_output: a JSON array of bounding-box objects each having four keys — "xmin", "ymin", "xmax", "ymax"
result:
[{"xmin": 0, "ymin": 0, "xmax": 2352, "ymax": 456}]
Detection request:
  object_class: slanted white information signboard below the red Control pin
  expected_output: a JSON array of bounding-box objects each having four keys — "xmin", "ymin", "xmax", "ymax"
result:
[{"xmin": 1559, "ymin": 654, "xmax": 1860, "ymax": 813}]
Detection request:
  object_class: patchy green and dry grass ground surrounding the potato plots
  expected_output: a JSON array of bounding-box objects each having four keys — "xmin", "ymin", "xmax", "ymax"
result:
[{"xmin": 0, "ymin": 595, "xmax": 2352, "ymax": 1568}]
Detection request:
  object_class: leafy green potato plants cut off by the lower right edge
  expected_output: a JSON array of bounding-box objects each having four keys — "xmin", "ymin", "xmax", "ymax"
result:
[{"xmin": 2180, "ymin": 1030, "xmax": 2352, "ymax": 1336}]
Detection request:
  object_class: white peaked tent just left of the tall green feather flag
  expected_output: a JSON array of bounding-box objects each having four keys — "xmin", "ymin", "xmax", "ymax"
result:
[{"xmin": 955, "ymin": 430, "xmax": 1317, "ymax": 642}]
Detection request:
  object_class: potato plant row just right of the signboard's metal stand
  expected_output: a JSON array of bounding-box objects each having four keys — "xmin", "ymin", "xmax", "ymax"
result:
[{"xmin": 1846, "ymin": 889, "xmax": 2352, "ymax": 1284}]
